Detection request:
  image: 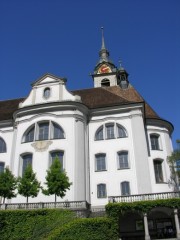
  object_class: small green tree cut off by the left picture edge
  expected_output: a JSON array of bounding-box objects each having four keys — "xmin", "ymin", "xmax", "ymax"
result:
[{"xmin": 0, "ymin": 167, "xmax": 17, "ymax": 204}]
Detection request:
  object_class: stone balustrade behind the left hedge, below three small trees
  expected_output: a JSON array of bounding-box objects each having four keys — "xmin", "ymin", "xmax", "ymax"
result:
[{"xmin": 0, "ymin": 201, "xmax": 90, "ymax": 210}]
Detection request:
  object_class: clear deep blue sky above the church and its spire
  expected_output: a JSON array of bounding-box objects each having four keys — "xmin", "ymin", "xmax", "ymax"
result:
[{"xmin": 0, "ymin": 0, "xmax": 180, "ymax": 147}]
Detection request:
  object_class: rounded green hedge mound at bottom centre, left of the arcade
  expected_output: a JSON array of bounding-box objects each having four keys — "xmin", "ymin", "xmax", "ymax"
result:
[{"xmin": 47, "ymin": 217, "xmax": 118, "ymax": 240}]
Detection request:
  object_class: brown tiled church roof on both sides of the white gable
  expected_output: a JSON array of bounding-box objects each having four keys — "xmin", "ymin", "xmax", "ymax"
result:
[{"xmin": 0, "ymin": 85, "xmax": 160, "ymax": 121}]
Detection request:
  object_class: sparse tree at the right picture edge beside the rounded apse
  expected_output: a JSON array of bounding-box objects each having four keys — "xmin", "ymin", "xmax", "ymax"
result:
[{"xmin": 167, "ymin": 140, "xmax": 180, "ymax": 191}]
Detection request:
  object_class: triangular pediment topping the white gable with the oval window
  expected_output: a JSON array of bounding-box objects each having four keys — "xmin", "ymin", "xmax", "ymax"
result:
[{"xmin": 31, "ymin": 73, "xmax": 67, "ymax": 87}]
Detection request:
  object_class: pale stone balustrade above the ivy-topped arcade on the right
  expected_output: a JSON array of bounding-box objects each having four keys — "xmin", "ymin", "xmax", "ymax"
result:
[{"xmin": 108, "ymin": 192, "xmax": 180, "ymax": 203}]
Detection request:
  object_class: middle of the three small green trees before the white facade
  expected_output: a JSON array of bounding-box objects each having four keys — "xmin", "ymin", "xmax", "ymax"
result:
[{"xmin": 18, "ymin": 164, "xmax": 41, "ymax": 203}]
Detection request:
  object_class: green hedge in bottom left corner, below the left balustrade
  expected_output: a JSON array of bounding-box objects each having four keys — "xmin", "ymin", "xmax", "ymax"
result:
[{"xmin": 0, "ymin": 209, "xmax": 76, "ymax": 240}]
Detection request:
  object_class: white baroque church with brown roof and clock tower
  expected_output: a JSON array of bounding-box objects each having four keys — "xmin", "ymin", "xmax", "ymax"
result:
[{"xmin": 0, "ymin": 30, "xmax": 173, "ymax": 207}]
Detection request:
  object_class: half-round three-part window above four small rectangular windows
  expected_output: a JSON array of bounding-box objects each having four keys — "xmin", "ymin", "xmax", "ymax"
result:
[{"xmin": 95, "ymin": 122, "xmax": 127, "ymax": 140}]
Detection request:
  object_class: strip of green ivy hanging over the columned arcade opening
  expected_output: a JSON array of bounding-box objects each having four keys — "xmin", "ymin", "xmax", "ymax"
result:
[{"xmin": 106, "ymin": 198, "xmax": 180, "ymax": 218}]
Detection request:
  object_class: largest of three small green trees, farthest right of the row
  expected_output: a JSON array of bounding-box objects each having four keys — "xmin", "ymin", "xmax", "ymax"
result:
[{"xmin": 43, "ymin": 156, "xmax": 72, "ymax": 203}]
